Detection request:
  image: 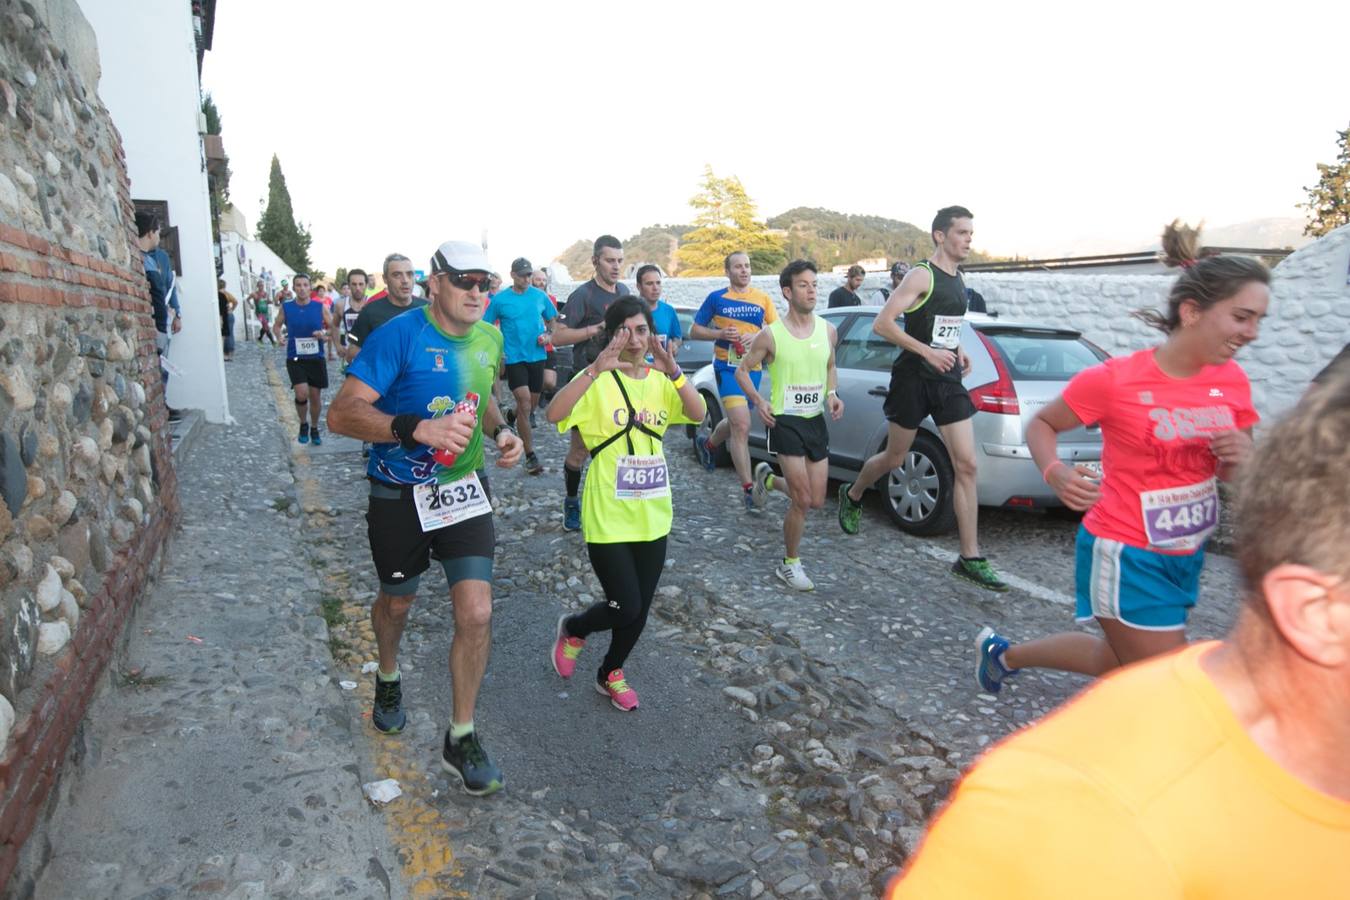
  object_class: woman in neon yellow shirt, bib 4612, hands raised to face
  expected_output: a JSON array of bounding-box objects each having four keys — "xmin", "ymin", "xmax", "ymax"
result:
[{"xmin": 548, "ymin": 297, "xmax": 705, "ymax": 711}]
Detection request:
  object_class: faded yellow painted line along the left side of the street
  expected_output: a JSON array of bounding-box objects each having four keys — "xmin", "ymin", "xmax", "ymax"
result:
[{"xmin": 263, "ymin": 356, "xmax": 468, "ymax": 897}]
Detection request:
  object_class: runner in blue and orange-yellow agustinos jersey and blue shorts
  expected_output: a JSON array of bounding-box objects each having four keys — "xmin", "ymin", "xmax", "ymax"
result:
[{"xmin": 689, "ymin": 251, "xmax": 778, "ymax": 513}]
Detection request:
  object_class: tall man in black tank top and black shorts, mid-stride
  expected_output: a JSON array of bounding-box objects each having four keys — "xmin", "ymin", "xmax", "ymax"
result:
[{"xmin": 838, "ymin": 206, "xmax": 1008, "ymax": 591}]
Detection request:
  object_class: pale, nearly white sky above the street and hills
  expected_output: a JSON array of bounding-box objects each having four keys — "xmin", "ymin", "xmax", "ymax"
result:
[{"xmin": 203, "ymin": 0, "xmax": 1350, "ymax": 275}]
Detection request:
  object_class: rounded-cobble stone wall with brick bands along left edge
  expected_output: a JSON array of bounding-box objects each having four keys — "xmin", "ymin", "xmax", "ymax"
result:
[{"xmin": 0, "ymin": 0, "xmax": 177, "ymax": 885}]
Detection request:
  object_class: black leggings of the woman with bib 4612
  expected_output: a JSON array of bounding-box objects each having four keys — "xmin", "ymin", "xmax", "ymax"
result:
[{"xmin": 566, "ymin": 536, "xmax": 666, "ymax": 680}]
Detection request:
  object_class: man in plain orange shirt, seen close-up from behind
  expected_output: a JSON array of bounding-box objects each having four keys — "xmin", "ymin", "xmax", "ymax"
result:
[{"xmin": 888, "ymin": 372, "xmax": 1350, "ymax": 900}]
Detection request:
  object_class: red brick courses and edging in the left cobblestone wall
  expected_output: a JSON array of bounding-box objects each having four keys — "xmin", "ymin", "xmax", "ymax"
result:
[{"xmin": 0, "ymin": 219, "xmax": 180, "ymax": 891}]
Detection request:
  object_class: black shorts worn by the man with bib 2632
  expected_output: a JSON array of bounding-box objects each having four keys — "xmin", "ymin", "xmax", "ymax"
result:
[{"xmin": 366, "ymin": 472, "xmax": 497, "ymax": 595}]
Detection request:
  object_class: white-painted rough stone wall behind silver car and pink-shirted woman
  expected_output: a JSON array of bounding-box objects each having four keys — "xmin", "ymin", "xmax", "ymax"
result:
[{"xmin": 965, "ymin": 225, "xmax": 1350, "ymax": 420}]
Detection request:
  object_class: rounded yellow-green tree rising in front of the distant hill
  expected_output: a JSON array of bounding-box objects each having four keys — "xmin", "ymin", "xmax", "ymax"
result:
[{"xmin": 678, "ymin": 166, "xmax": 787, "ymax": 275}]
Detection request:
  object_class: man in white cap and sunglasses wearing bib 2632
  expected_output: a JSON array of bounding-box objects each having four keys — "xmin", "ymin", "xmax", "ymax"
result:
[{"xmin": 328, "ymin": 240, "xmax": 524, "ymax": 795}]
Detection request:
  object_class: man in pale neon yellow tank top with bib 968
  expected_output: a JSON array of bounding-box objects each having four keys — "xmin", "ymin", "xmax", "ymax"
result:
[{"xmin": 736, "ymin": 259, "xmax": 844, "ymax": 591}]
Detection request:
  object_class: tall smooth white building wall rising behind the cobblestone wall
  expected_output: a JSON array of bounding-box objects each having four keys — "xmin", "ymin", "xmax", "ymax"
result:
[{"xmin": 80, "ymin": 0, "xmax": 230, "ymax": 422}]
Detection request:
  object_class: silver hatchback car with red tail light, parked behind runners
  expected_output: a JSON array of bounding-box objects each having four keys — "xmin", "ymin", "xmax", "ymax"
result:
[{"xmin": 694, "ymin": 306, "xmax": 1107, "ymax": 534}]
